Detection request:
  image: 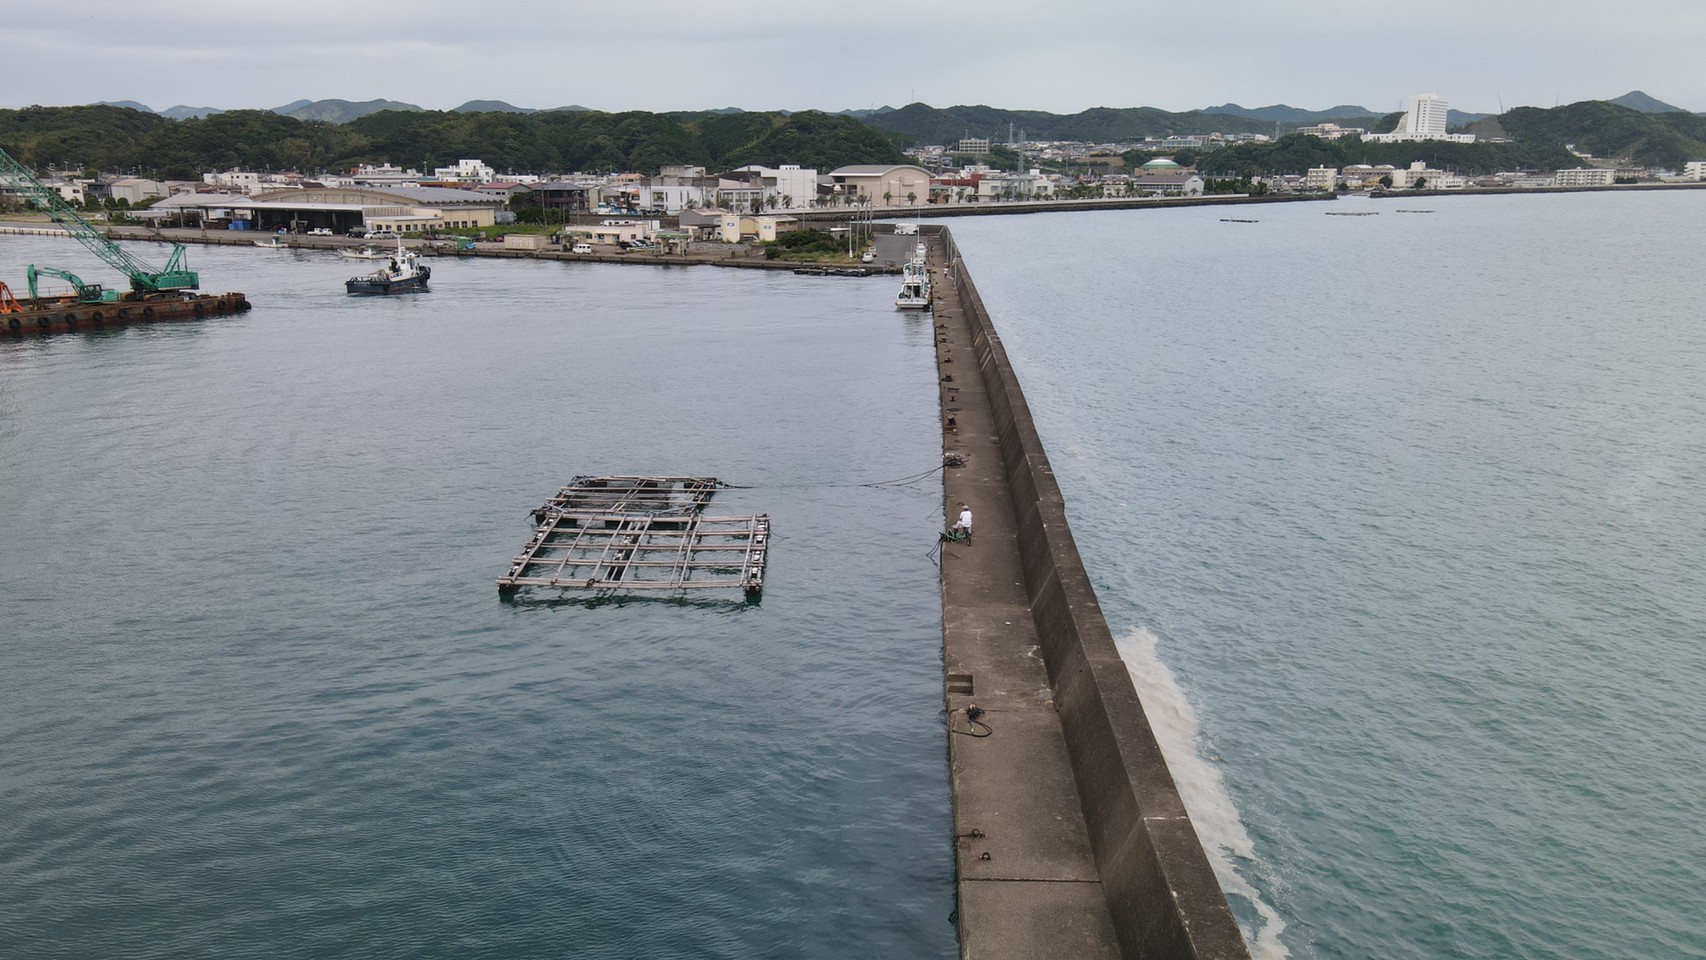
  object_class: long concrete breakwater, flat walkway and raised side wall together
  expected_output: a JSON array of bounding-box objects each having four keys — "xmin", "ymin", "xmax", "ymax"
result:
[{"xmin": 925, "ymin": 227, "xmax": 1249, "ymax": 960}]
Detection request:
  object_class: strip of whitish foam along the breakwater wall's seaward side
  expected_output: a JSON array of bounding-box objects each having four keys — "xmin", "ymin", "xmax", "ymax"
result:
[{"xmin": 1114, "ymin": 627, "xmax": 1291, "ymax": 960}]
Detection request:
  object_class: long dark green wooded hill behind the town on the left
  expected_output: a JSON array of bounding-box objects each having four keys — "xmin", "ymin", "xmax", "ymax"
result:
[{"xmin": 0, "ymin": 106, "xmax": 904, "ymax": 179}]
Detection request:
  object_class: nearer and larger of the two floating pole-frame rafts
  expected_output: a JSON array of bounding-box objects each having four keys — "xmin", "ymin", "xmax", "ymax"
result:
[{"xmin": 498, "ymin": 512, "xmax": 769, "ymax": 595}]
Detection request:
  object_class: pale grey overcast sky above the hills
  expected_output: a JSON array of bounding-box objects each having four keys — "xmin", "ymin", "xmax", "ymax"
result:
[{"xmin": 13, "ymin": 0, "xmax": 1706, "ymax": 113}]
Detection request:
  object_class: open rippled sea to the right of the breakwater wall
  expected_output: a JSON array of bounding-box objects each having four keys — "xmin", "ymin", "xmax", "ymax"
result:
[{"xmin": 952, "ymin": 193, "xmax": 1706, "ymax": 960}]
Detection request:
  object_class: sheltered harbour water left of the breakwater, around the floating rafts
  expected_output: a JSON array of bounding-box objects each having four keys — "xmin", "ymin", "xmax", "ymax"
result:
[{"xmin": 0, "ymin": 237, "xmax": 955, "ymax": 958}]
